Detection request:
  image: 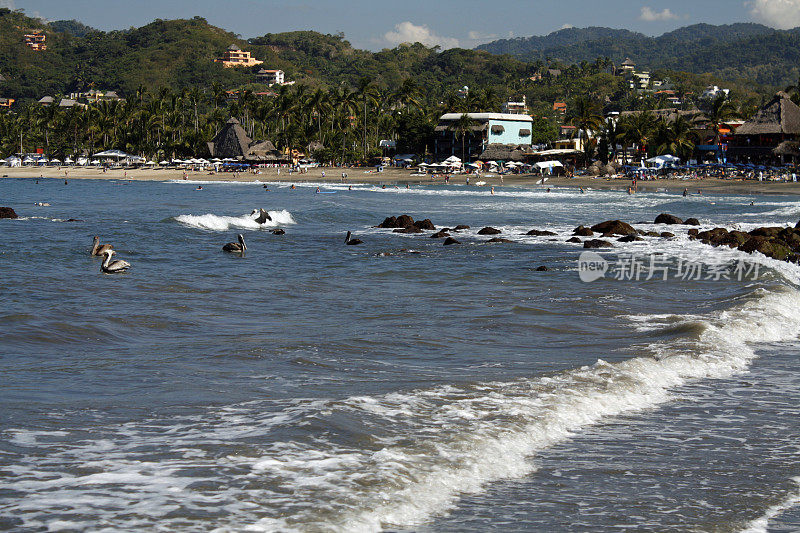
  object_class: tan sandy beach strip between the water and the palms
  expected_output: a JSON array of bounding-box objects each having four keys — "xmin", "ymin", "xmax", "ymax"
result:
[{"xmin": 0, "ymin": 167, "xmax": 800, "ymax": 194}]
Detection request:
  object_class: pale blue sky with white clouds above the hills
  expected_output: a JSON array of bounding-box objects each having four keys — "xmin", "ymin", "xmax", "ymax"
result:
[{"xmin": 0, "ymin": 0, "xmax": 800, "ymax": 50}]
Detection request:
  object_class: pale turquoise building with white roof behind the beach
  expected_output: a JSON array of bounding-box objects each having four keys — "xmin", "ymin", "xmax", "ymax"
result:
[{"xmin": 435, "ymin": 113, "xmax": 533, "ymax": 160}]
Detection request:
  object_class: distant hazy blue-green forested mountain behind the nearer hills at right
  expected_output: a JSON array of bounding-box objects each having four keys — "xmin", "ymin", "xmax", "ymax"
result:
[{"xmin": 478, "ymin": 23, "xmax": 800, "ymax": 85}]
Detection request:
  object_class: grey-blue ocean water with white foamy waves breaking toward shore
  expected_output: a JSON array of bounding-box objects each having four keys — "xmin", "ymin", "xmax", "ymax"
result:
[{"xmin": 0, "ymin": 179, "xmax": 800, "ymax": 532}]
